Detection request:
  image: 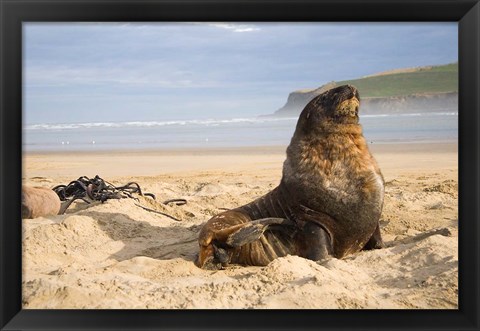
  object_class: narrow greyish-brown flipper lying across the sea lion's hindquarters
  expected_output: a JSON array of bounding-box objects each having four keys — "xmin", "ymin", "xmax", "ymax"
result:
[{"xmin": 226, "ymin": 217, "xmax": 294, "ymax": 247}]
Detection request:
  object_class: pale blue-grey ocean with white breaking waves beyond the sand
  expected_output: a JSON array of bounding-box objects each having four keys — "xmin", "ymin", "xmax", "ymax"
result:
[{"xmin": 23, "ymin": 112, "xmax": 458, "ymax": 152}]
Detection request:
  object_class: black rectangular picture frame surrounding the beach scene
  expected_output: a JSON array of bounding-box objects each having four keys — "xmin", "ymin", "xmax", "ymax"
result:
[{"xmin": 0, "ymin": 0, "xmax": 480, "ymax": 330}]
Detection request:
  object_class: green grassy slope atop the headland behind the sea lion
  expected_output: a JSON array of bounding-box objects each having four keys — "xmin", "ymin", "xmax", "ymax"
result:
[{"xmin": 335, "ymin": 63, "xmax": 458, "ymax": 98}]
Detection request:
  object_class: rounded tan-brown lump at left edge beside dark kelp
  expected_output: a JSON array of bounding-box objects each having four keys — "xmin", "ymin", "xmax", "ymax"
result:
[{"xmin": 22, "ymin": 186, "xmax": 61, "ymax": 219}]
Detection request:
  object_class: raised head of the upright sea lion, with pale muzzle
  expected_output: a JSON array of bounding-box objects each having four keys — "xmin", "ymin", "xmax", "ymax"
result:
[{"xmin": 296, "ymin": 85, "xmax": 360, "ymax": 134}]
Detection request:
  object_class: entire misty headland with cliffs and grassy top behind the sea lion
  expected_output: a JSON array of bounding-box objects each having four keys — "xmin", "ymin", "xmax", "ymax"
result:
[{"xmin": 270, "ymin": 63, "xmax": 458, "ymax": 117}]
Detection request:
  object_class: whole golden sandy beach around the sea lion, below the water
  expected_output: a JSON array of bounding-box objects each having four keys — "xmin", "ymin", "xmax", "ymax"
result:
[{"xmin": 23, "ymin": 143, "xmax": 458, "ymax": 309}]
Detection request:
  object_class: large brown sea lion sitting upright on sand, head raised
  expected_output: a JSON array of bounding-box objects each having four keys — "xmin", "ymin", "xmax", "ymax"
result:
[{"xmin": 195, "ymin": 85, "xmax": 384, "ymax": 269}]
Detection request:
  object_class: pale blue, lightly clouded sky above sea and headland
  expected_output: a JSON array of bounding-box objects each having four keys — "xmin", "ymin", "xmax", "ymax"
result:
[{"xmin": 23, "ymin": 22, "xmax": 458, "ymax": 125}]
